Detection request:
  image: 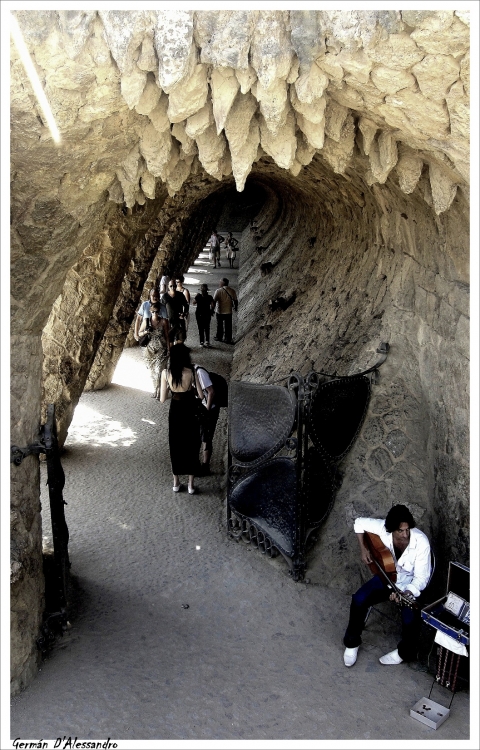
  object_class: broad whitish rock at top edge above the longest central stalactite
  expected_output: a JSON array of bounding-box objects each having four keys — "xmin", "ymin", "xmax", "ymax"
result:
[{"xmin": 194, "ymin": 10, "xmax": 259, "ymax": 70}]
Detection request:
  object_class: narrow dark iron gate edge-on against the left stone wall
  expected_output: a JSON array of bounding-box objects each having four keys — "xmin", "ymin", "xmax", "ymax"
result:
[{"xmin": 10, "ymin": 404, "xmax": 70, "ymax": 651}]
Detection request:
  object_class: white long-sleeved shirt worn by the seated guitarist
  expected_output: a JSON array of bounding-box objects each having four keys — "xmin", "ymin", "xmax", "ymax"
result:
[{"xmin": 353, "ymin": 518, "xmax": 431, "ymax": 596}]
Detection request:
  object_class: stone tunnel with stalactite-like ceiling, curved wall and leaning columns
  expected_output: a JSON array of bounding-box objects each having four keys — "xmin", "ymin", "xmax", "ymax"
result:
[{"xmin": 11, "ymin": 10, "xmax": 470, "ymax": 692}]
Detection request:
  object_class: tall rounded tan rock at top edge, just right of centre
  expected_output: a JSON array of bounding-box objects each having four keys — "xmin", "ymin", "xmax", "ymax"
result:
[{"xmin": 250, "ymin": 10, "xmax": 293, "ymax": 91}]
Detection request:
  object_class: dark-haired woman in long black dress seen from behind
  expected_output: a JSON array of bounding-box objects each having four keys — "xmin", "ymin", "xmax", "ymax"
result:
[{"xmin": 160, "ymin": 343, "xmax": 201, "ymax": 495}]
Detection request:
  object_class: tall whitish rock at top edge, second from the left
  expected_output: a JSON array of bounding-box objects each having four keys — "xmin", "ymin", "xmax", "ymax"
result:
[{"xmin": 154, "ymin": 10, "xmax": 197, "ymax": 94}]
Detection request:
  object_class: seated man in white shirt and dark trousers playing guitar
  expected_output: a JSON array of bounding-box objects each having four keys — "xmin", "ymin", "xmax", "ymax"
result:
[{"xmin": 343, "ymin": 505, "xmax": 431, "ymax": 667}]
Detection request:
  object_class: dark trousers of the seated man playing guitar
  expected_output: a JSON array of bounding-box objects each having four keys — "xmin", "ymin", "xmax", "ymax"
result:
[{"xmin": 343, "ymin": 576, "xmax": 422, "ymax": 661}]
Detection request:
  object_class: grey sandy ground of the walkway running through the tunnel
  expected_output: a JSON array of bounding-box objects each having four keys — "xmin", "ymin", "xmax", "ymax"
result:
[{"xmin": 10, "ymin": 245, "xmax": 469, "ymax": 747}]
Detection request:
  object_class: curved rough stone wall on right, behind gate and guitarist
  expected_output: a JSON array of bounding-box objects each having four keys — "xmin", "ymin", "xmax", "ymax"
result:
[{"xmin": 232, "ymin": 159, "xmax": 469, "ymax": 589}]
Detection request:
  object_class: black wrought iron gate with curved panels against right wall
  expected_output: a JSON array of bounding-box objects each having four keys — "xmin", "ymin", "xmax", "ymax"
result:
[{"xmin": 227, "ymin": 343, "xmax": 389, "ymax": 581}]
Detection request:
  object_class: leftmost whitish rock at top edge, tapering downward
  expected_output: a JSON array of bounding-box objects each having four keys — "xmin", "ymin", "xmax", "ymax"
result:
[{"xmin": 98, "ymin": 10, "xmax": 152, "ymax": 74}]
